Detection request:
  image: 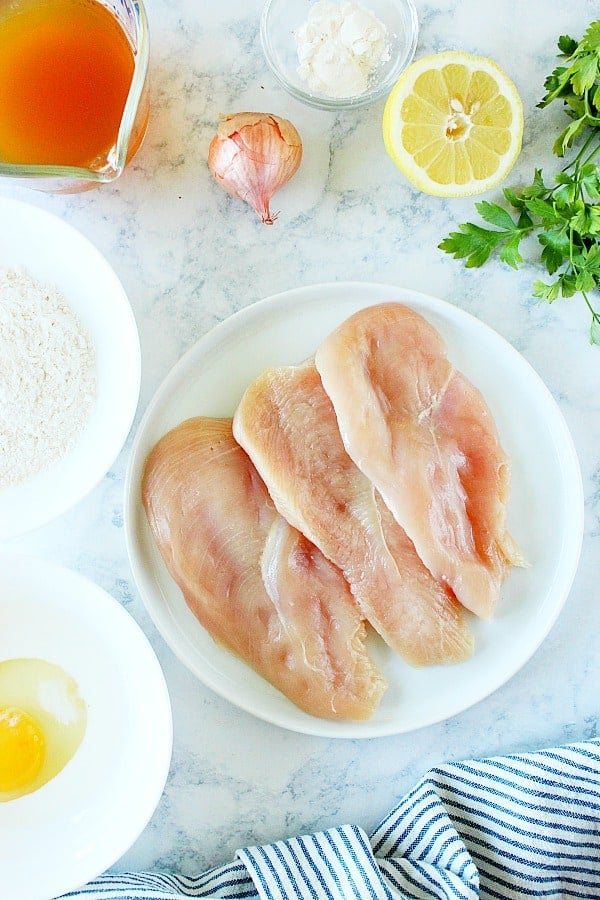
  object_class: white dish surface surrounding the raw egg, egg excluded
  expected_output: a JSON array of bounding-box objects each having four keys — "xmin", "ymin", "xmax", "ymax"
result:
[{"xmin": 0, "ymin": 552, "xmax": 172, "ymax": 900}]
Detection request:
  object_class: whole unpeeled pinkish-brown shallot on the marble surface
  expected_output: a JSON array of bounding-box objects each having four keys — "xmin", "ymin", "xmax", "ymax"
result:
[{"xmin": 208, "ymin": 112, "xmax": 302, "ymax": 225}]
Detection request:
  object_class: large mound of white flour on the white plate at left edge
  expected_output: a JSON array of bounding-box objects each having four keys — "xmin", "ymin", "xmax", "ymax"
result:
[{"xmin": 0, "ymin": 269, "xmax": 96, "ymax": 488}]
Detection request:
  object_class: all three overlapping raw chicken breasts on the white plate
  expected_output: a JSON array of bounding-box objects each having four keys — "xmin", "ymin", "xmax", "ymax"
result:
[{"xmin": 142, "ymin": 303, "xmax": 522, "ymax": 719}]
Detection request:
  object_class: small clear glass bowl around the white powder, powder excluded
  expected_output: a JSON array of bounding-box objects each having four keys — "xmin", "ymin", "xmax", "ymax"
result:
[{"xmin": 260, "ymin": 0, "xmax": 419, "ymax": 110}]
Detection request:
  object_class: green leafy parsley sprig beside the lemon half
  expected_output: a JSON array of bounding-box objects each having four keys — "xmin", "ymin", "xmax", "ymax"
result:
[{"xmin": 439, "ymin": 20, "xmax": 600, "ymax": 344}]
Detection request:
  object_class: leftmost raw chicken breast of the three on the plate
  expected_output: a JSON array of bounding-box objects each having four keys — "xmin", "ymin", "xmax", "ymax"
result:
[{"xmin": 142, "ymin": 417, "xmax": 385, "ymax": 720}]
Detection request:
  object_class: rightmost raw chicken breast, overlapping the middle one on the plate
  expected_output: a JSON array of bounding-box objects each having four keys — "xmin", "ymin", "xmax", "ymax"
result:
[{"xmin": 315, "ymin": 303, "xmax": 523, "ymax": 618}]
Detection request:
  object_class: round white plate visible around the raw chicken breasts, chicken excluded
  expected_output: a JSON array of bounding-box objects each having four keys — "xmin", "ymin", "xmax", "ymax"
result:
[{"xmin": 125, "ymin": 283, "xmax": 583, "ymax": 738}]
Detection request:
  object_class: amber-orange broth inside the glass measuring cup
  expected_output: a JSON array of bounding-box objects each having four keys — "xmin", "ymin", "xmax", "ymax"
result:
[{"xmin": 0, "ymin": 0, "xmax": 134, "ymax": 168}]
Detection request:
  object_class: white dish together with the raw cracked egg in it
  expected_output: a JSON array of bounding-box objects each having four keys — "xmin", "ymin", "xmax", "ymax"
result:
[{"xmin": 0, "ymin": 552, "xmax": 172, "ymax": 900}]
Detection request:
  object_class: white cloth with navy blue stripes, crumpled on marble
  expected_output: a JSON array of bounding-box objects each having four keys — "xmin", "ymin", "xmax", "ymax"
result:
[{"xmin": 59, "ymin": 739, "xmax": 600, "ymax": 900}]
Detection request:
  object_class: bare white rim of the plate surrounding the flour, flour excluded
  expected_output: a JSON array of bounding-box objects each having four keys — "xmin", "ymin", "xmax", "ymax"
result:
[{"xmin": 0, "ymin": 198, "xmax": 140, "ymax": 540}]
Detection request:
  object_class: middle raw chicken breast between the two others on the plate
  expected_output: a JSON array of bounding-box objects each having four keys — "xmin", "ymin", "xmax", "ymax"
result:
[{"xmin": 233, "ymin": 362, "xmax": 472, "ymax": 665}]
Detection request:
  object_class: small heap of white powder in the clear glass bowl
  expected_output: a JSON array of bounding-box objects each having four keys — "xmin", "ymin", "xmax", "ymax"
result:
[{"xmin": 296, "ymin": 0, "xmax": 390, "ymax": 98}]
